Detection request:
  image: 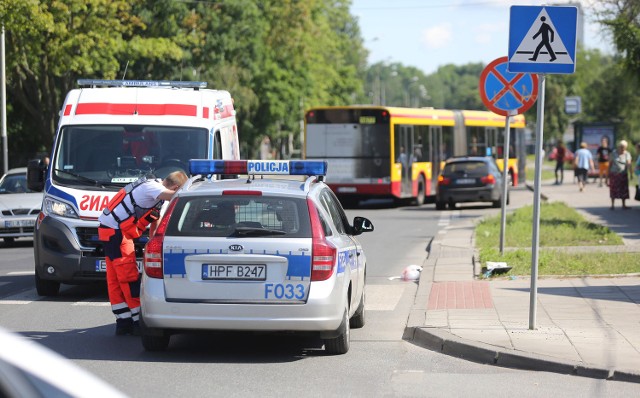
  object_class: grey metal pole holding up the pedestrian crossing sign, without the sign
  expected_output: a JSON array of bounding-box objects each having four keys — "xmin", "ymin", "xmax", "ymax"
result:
[{"xmin": 529, "ymin": 74, "xmax": 545, "ymax": 330}]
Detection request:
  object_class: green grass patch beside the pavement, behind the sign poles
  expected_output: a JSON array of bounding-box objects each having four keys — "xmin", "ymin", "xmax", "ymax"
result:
[{"xmin": 475, "ymin": 202, "xmax": 640, "ymax": 275}]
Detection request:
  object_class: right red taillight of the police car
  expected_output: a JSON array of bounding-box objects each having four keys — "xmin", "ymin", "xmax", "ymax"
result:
[{"xmin": 307, "ymin": 199, "xmax": 337, "ymax": 282}]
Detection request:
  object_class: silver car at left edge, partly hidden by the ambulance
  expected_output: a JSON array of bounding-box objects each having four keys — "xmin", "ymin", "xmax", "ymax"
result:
[{"xmin": 0, "ymin": 167, "xmax": 42, "ymax": 243}]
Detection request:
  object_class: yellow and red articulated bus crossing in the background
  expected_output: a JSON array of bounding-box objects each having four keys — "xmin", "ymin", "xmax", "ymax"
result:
[{"xmin": 304, "ymin": 105, "xmax": 526, "ymax": 206}]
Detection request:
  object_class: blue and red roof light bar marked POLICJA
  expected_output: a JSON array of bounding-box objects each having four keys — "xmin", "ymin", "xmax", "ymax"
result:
[{"xmin": 189, "ymin": 159, "xmax": 327, "ymax": 176}]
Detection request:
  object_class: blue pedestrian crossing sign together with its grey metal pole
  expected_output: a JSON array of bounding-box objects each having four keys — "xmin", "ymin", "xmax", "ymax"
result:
[{"xmin": 507, "ymin": 6, "xmax": 578, "ymax": 329}]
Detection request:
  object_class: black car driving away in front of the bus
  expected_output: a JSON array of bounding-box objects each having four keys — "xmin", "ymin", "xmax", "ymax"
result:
[{"xmin": 436, "ymin": 156, "xmax": 509, "ymax": 210}]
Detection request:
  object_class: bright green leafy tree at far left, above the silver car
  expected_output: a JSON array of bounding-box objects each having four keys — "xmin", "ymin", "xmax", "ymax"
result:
[{"xmin": 0, "ymin": 0, "xmax": 182, "ymax": 163}]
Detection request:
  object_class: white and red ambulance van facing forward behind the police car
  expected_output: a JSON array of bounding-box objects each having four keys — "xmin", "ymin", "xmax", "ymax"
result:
[{"xmin": 27, "ymin": 79, "xmax": 240, "ymax": 296}]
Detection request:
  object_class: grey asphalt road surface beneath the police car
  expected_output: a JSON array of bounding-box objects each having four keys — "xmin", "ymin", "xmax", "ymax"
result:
[{"xmin": 0, "ymin": 203, "xmax": 638, "ymax": 397}]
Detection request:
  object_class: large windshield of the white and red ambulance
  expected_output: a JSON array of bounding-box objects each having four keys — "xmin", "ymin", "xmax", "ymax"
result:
[{"xmin": 51, "ymin": 125, "xmax": 208, "ymax": 188}]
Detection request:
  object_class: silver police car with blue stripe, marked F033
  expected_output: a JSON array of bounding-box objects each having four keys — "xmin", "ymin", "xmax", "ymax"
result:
[{"xmin": 141, "ymin": 160, "xmax": 373, "ymax": 354}]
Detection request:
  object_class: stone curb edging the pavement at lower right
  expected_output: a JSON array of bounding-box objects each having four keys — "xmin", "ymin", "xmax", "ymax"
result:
[{"xmin": 405, "ymin": 327, "xmax": 640, "ymax": 383}]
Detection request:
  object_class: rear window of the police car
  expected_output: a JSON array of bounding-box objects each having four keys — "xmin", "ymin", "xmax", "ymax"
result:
[{"xmin": 167, "ymin": 195, "xmax": 311, "ymax": 239}]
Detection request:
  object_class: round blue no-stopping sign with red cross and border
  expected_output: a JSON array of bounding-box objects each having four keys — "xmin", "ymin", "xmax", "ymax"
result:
[{"xmin": 480, "ymin": 57, "xmax": 538, "ymax": 116}]
